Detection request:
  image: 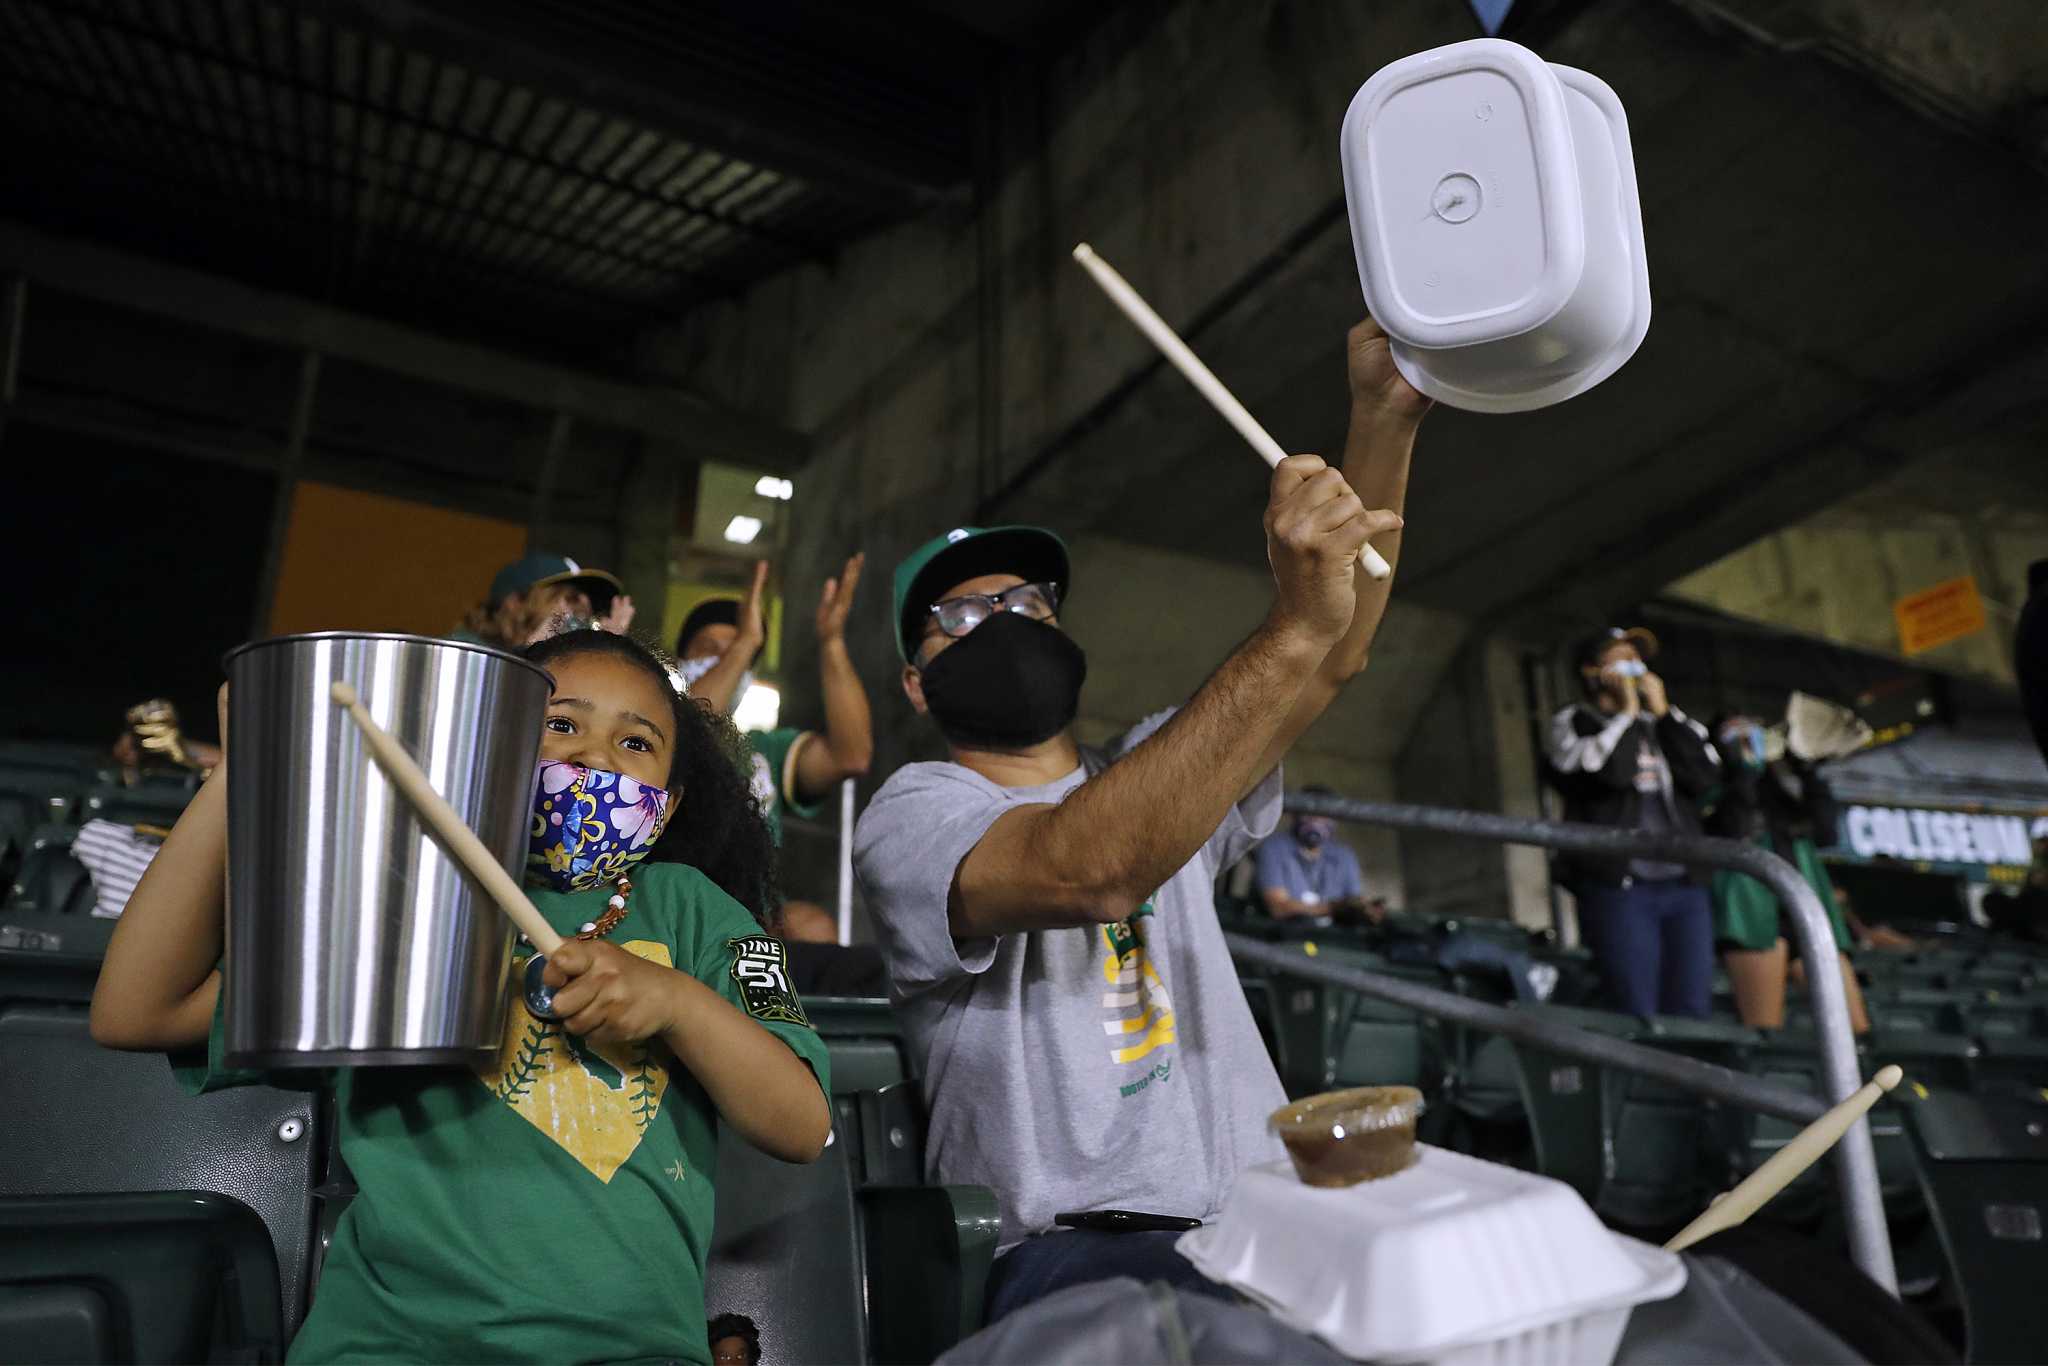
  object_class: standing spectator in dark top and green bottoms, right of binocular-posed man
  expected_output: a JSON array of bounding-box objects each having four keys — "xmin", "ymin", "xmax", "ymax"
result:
[{"xmin": 1702, "ymin": 715, "xmax": 1870, "ymax": 1034}]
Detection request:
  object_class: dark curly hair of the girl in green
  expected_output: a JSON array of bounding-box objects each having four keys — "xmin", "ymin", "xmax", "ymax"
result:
[{"xmin": 524, "ymin": 629, "xmax": 782, "ymax": 930}]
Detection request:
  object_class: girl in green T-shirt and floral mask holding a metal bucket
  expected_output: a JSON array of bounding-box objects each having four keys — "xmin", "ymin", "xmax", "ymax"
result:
[{"xmin": 92, "ymin": 629, "xmax": 831, "ymax": 1366}]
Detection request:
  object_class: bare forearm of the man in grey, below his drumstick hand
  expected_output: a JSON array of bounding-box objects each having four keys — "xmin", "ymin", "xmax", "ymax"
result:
[{"xmin": 1036, "ymin": 621, "xmax": 1327, "ymax": 917}]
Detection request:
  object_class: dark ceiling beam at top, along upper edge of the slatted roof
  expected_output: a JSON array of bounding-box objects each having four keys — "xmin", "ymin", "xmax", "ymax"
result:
[{"xmin": 299, "ymin": 0, "xmax": 969, "ymax": 211}]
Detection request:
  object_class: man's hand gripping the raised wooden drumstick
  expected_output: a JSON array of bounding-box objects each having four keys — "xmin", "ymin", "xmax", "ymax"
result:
[{"xmin": 1266, "ymin": 455, "xmax": 1401, "ymax": 645}]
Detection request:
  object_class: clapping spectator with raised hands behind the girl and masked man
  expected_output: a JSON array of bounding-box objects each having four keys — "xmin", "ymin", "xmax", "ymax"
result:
[{"xmin": 676, "ymin": 555, "xmax": 874, "ymax": 844}]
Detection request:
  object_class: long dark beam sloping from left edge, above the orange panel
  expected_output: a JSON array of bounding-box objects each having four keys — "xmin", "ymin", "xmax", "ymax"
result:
[{"xmin": 0, "ymin": 221, "xmax": 811, "ymax": 473}]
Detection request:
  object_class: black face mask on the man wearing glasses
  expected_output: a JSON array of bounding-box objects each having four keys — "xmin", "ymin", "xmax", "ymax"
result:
[{"xmin": 920, "ymin": 612, "xmax": 1087, "ymax": 750}]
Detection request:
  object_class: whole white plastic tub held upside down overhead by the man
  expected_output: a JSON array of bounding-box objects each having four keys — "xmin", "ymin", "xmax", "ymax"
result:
[{"xmin": 1341, "ymin": 39, "xmax": 1651, "ymax": 412}]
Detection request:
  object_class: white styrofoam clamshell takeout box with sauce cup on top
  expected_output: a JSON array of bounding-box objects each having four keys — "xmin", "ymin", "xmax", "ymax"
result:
[{"xmin": 1178, "ymin": 1143, "xmax": 1686, "ymax": 1366}]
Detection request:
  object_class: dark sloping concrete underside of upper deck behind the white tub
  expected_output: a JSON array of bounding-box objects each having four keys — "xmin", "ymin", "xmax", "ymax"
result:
[{"xmin": 993, "ymin": 2, "xmax": 2048, "ymax": 629}]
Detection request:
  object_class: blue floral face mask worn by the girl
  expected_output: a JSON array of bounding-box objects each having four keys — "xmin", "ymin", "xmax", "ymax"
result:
[{"xmin": 526, "ymin": 760, "xmax": 668, "ymax": 891}]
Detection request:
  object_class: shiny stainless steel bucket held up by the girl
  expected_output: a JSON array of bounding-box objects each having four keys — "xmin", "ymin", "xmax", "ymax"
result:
[{"xmin": 223, "ymin": 631, "xmax": 551, "ymax": 1067}]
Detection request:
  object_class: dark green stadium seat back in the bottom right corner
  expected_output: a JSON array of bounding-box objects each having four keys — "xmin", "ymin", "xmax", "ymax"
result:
[{"xmin": 1901, "ymin": 1092, "xmax": 2048, "ymax": 1362}]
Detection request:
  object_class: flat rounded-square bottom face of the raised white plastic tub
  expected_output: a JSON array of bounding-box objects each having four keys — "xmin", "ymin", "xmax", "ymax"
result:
[{"xmin": 1341, "ymin": 39, "xmax": 1585, "ymax": 346}]
